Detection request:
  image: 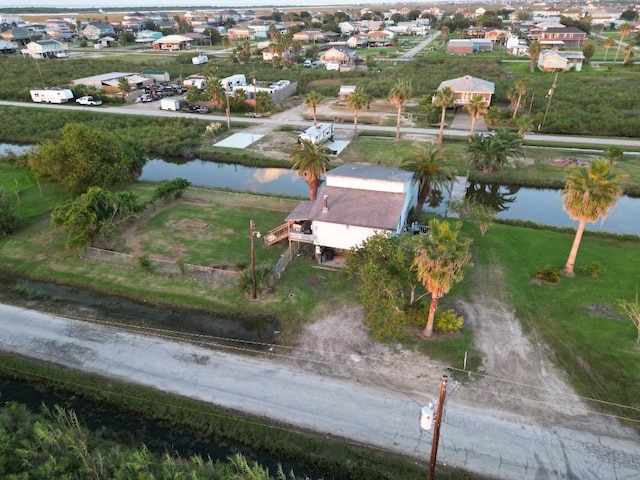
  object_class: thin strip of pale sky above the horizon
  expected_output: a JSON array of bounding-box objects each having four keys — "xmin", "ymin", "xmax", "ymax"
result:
[{"xmin": 0, "ymin": 0, "xmax": 380, "ymax": 11}]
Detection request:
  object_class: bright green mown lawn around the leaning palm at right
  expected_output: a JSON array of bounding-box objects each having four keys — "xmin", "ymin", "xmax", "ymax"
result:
[{"xmin": 464, "ymin": 225, "xmax": 640, "ymax": 428}]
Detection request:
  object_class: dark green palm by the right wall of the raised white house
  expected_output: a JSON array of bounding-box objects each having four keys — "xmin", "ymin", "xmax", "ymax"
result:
[{"xmin": 401, "ymin": 143, "xmax": 454, "ymax": 221}]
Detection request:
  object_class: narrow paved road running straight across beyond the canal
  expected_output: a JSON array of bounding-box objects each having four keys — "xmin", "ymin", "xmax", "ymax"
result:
[{"xmin": 5, "ymin": 101, "xmax": 640, "ymax": 149}]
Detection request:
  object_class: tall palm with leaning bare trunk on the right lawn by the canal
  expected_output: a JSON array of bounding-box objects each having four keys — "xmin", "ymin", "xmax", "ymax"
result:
[{"xmin": 562, "ymin": 158, "xmax": 622, "ymax": 276}]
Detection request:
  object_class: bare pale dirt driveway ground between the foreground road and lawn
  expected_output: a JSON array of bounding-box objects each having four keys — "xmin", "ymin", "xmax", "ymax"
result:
[{"xmin": 295, "ymin": 260, "xmax": 632, "ymax": 431}]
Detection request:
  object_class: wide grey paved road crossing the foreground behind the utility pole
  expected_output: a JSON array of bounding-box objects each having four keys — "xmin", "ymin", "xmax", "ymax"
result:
[{"xmin": 0, "ymin": 305, "xmax": 640, "ymax": 480}]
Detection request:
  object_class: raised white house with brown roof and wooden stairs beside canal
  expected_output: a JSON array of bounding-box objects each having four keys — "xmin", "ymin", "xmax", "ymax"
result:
[{"xmin": 272, "ymin": 164, "xmax": 418, "ymax": 260}]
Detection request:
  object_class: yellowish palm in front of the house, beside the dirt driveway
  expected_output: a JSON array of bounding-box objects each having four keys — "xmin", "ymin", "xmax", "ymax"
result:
[{"xmin": 412, "ymin": 219, "xmax": 471, "ymax": 337}]
